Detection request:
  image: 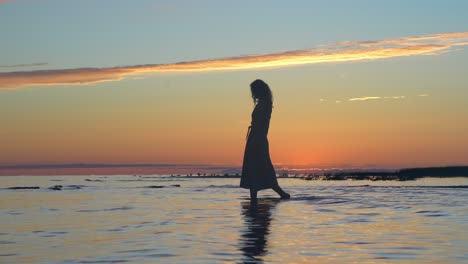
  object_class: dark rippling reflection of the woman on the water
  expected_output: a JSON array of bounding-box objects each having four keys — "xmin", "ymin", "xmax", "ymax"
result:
[{"xmin": 240, "ymin": 199, "xmax": 280, "ymax": 263}]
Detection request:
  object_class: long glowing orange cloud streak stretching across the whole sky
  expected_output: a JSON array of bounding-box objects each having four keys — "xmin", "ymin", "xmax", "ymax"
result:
[{"xmin": 0, "ymin": 32, "xmax": 468, "ymax": 88}]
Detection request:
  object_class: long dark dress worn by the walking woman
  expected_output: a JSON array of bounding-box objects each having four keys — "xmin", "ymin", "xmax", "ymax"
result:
[{"xmin": 240, "ymin": 101, "xmax": 278, "ymax": 191}]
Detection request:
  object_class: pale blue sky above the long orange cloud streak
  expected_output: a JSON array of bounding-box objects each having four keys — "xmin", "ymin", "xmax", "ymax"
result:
[{"xmin": 0, "ymin": 0, "xmax": 468, "ymax": 68}]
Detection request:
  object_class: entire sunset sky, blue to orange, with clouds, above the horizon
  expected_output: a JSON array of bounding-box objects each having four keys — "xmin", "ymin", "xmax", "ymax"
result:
[{"xmin": 0, "ymin": 0, "xmax": 468, "ymax": 174}]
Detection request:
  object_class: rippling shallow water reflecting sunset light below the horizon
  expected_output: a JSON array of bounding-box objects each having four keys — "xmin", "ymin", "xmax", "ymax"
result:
[{"xmin": 0, "ymin": 176, "xmax": 468, "ymax": 263}]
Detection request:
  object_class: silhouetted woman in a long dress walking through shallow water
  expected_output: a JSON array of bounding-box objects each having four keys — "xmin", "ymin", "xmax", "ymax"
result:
[{"xmin": 240, "ymin": 80, "xmax": 290, "ymax": 202}]
